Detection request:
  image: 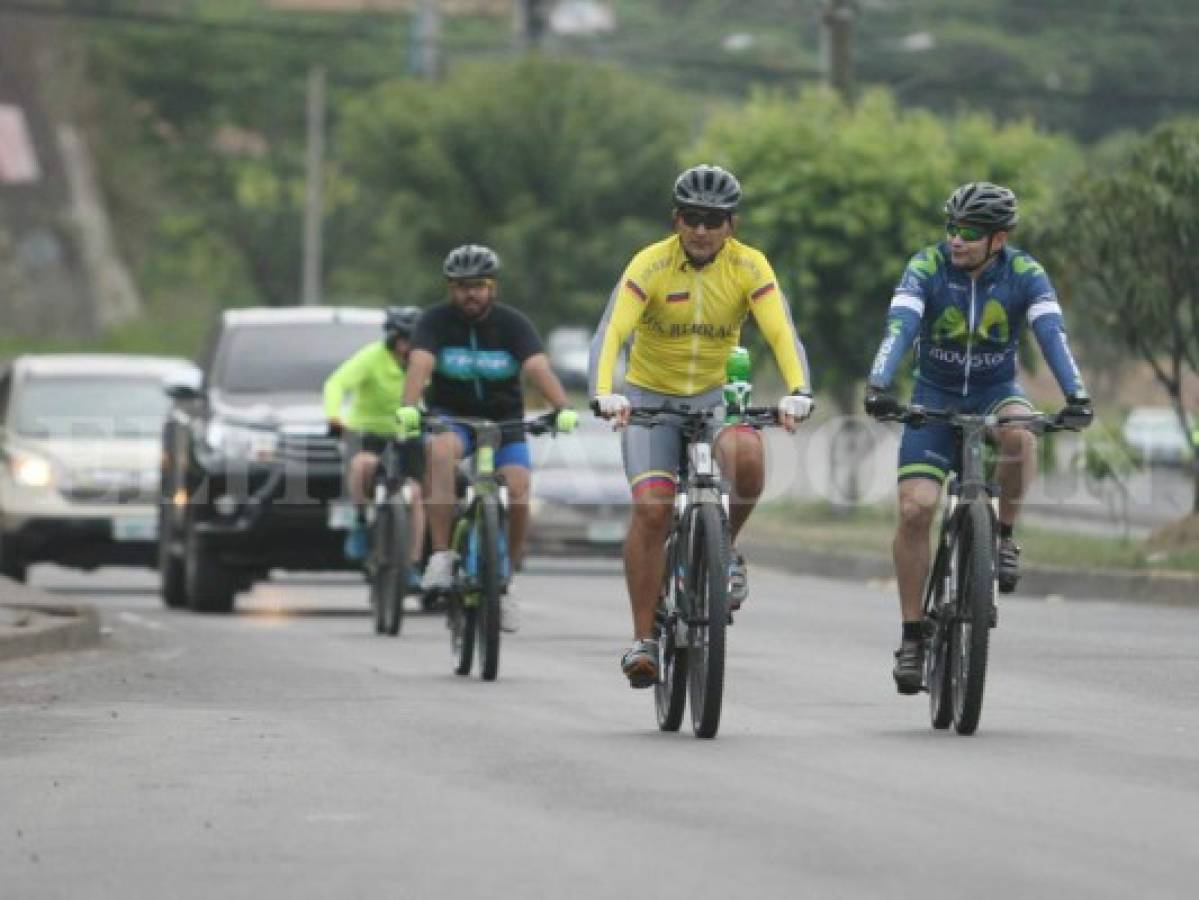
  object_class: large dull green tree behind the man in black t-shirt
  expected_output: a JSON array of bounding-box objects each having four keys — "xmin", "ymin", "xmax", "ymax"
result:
[{"xmin": 331, "ymin": 59, "xmax": 687, "ymax": 327}]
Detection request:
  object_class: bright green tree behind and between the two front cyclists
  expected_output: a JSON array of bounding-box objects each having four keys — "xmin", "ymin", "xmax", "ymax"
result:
[{"xmin": 689, "ymin": 89, "xmax": 1076, "ymax": 411}]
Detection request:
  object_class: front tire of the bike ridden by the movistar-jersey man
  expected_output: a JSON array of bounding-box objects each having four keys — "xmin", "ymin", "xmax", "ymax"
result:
[{"xmin": 950, "ymin": 503, "xmax": 995, "ymax": 735}]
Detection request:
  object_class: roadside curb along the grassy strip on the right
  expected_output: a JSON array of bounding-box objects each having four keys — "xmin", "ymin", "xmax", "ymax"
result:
[{"xmin": 739, "ymin": 534, "xmax": 1199, "ymax": 606}]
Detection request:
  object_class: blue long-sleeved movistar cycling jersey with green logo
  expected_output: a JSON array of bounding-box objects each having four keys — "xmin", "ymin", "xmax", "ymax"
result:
[{"xmin": 869, "ymin": 241, "xmax": 1085, "ymax": 397}]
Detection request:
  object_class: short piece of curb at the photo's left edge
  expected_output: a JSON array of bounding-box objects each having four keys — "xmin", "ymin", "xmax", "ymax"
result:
[{"xmin": 0, "ymin": 578, "xmax": 100, "ymax": 663}]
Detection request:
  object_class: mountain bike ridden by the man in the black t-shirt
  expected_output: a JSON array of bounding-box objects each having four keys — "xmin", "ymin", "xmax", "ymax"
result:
[{"xmin": 424, "ymin": 412, "xmax": 558, "ymax": 681}]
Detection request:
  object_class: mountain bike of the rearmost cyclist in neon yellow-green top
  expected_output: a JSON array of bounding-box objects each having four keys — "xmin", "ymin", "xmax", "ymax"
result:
[{"xmin": 366, "ymin": 439, "xmax": 420, "ymax": 636}]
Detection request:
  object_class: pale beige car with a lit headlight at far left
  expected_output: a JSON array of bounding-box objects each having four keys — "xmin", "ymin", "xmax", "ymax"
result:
[{"xmin": 0, "ymin": 354, "xmax": 195, "ymax": 580}]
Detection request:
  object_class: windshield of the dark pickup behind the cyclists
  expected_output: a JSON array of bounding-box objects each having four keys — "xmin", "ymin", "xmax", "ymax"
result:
[{"xmin": 212, "ymin": 322, "xmax": 380, "ymax": 394}]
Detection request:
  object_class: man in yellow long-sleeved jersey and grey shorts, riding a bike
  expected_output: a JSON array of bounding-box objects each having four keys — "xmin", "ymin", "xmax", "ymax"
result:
[{"xmin": 591, "ymin": 165, "xmax": 813, "ymax": 688}]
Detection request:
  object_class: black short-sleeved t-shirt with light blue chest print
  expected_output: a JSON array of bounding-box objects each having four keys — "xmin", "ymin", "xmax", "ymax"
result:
[{"xmin": 411, "ymin": 303, "xmax": 542, "ymax": 429}]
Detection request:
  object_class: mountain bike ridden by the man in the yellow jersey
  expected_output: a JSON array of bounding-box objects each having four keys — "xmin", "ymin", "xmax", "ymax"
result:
[{"xmin": 629, "ymin": 406, "xmax": 777, "ymax": 738}]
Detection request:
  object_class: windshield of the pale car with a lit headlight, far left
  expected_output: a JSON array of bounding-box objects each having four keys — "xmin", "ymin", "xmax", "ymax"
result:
[{"xmin": 13, "ymin": 375, "xmax": 169, "ymax": 440}]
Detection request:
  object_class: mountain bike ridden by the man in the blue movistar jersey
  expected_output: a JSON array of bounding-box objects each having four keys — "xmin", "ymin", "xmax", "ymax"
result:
[{"xmin": 885, "ymin": 405, "xmax": 1078, "ymax": 735}]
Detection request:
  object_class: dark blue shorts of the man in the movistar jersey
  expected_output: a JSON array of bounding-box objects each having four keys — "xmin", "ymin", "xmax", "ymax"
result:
[{"xmin": 899, "ymin": 380, "xmax": 1034, "ymax": 482}]
